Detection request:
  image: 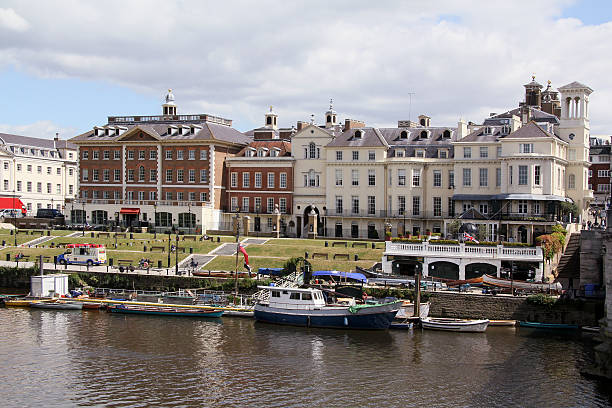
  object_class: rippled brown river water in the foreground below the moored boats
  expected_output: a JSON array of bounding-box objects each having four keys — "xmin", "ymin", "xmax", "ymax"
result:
[{"xmin": 0, "ymin": 308, "xmax": 612, "ymax": 407}]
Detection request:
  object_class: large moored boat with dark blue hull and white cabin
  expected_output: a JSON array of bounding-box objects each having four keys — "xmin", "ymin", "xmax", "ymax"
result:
[{"xmin": 255, "ymin": 286, "xmax": 402, "ymax": 329}]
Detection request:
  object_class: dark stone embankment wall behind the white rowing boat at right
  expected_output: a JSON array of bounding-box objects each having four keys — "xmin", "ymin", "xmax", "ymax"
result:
[{"xmin": 429, "ymin": 292, "xmax": 603, "ymax": 326}]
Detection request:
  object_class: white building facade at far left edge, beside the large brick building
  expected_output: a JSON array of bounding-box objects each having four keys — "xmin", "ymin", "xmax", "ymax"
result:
[{"xmin": 0, "ymin": 133, "xmax": 78, "ymax": 216}]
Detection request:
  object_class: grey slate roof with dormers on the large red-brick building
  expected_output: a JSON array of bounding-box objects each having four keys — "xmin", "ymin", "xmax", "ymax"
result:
[{"xmin": 70, "ymin": 122, "xmax": 252, "ymax": 145}]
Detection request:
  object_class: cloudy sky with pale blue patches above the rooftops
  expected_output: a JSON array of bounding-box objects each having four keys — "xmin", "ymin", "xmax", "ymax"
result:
[{"xmin": 0, "ymin": 0, "xmax": 612, "ymax": 138}]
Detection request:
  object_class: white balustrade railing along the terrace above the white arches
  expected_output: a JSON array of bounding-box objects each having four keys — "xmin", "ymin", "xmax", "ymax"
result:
[{"xmin": 385, "ymin": 242, "xmax": 542, "ymax": 262}]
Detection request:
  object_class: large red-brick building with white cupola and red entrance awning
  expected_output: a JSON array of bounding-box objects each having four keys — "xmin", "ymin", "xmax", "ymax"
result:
[{"xmin": 70, "ymin": 91, "xmax": 251, "ymax": 230}]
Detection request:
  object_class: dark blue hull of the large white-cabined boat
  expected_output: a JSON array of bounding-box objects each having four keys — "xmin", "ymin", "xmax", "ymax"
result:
[{"xmin": 254, "ymin": 301, "xmax": 401, "ymax": 330}]
